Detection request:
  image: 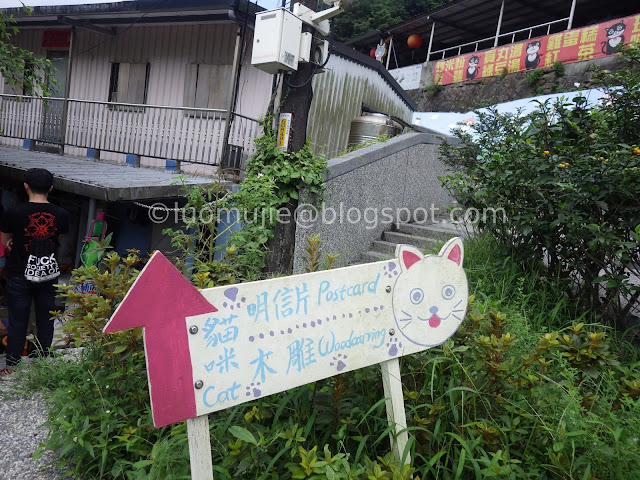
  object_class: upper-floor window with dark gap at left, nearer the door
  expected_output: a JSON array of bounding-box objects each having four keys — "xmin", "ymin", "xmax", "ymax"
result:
[{"xmin": 108, "ymin": 62, "xmax": 149, "ymax": 105}]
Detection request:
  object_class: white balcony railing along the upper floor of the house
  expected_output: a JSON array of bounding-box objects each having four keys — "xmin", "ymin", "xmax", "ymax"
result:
[{"xmin": 0, "ymin": 95, "xmax": 260, "ymax": 168}]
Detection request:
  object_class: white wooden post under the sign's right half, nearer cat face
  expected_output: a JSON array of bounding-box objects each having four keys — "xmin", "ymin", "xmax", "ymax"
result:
[{"xmin": 380, "ymin": 358, "xmax": 411, "ymax": 465}]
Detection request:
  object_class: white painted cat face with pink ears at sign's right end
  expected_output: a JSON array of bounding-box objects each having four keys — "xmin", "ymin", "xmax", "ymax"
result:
[{"xmin": 392, "ymin": 238, "xmax": 469, "ymax": 347}]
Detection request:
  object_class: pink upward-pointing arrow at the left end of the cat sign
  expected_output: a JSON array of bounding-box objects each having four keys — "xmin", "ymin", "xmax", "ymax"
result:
[{"xmin": 104, "ymin": 251, "xmax": 218, "ymax": 427}]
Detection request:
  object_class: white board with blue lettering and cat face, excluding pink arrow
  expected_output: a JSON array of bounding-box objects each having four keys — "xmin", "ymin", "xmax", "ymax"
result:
[{"xmin": 185, "ymin": 239, "xmax": 468, "ymax": 415}]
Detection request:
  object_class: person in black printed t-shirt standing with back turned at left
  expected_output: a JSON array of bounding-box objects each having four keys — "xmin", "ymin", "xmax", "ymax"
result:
[{"xmin": 0, "ymin": 168, "xmax": 69, "ymax": 374}]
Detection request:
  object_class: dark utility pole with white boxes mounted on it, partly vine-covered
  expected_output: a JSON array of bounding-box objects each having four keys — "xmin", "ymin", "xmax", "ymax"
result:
[{"xmin": 267, "ymin": 0, "xmax": 316, "ymax": 274}]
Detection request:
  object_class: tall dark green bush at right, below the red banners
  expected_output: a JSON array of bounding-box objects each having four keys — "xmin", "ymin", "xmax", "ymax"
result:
[{"xmin": 441, "ymin": 47, "xmax": 640, "ymax": 321}]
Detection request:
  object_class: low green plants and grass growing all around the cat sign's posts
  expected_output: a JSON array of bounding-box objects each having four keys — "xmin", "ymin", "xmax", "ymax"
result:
[{"xmin": 11, "ymin": 237, "xmax": 640, "ymax": 480}]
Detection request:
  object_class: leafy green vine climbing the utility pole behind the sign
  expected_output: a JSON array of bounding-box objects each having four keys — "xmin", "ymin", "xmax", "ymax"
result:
[{"xmin": 163, "ymin": 119, "xmax": 327, "ymax": 282}]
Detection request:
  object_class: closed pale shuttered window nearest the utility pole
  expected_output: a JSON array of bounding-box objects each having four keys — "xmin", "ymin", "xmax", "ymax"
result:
[{"xmin": 183, "ymin": 63, "xmax": 233, "ymax": 110}]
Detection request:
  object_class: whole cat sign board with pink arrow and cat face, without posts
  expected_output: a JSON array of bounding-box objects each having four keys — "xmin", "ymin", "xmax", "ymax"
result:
[{"xmin": 105, "ymin": 238, "xmax": 468, "ymax": 427}]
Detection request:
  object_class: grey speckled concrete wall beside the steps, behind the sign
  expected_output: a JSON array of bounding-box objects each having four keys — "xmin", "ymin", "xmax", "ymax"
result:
[{"xmin": 294, "ymin": 133, "xmax": 457, "ymax": 272}]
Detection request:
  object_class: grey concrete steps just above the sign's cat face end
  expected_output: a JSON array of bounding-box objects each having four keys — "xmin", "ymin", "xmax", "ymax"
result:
[{"xmin": 361, "ymin": 217, "xmax": 471, "ymax": 263}]
